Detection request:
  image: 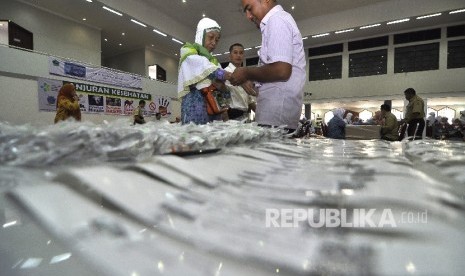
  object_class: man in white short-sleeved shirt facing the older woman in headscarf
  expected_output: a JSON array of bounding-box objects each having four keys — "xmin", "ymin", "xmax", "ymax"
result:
[{"xmin": 230, "ymin": 0, "xmax": 306, "ymax": 133}]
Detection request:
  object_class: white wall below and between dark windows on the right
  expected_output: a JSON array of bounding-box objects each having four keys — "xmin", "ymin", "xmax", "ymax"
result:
[{"xmin": 304, "ymin": 24, "xmax": 465, "ymax": 103}]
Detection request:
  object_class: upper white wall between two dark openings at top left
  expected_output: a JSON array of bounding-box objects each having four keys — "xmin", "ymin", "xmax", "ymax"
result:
[{"xmin": 0, "ymin": 0, "xmax": 101, "ymax": 65}]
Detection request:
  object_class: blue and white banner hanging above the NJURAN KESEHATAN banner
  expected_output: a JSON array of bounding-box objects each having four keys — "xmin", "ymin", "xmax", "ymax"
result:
[{"xmin": 49, "ymin": 57, "xmax": 142, "ymax": 89}]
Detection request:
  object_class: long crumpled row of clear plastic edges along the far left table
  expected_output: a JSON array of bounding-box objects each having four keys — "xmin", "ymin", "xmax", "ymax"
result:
[{"xmin": 0, "ymin": 119, "xmax": 281, "ymax": 167}]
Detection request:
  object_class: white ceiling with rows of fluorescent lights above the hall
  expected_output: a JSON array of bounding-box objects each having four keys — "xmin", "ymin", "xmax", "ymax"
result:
[{"xmin": 14, "ymin": 0, "xmax": 465, "ymax": 59}]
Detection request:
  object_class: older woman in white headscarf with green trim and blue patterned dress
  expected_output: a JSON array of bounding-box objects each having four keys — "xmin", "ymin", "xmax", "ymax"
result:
[{"xmin": 178, "ymin": 18, "xmax": 231, "ymax": 124}]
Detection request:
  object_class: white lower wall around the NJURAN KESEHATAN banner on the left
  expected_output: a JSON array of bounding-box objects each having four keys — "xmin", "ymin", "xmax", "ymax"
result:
[{"xmin": 0, "ymin": 45, "xmax": 180, "ymax": 125}]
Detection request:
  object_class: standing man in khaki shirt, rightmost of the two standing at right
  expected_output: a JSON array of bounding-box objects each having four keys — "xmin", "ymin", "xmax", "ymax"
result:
[{"xmin": 401, "ymin": 88, "xmax": 425, "ymax": 139}]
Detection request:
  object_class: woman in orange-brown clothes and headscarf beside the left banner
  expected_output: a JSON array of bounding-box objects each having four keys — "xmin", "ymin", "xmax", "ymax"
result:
[{"xmin": 55, "ymin": 83, "xmax": 81, "ymax": 124}]
